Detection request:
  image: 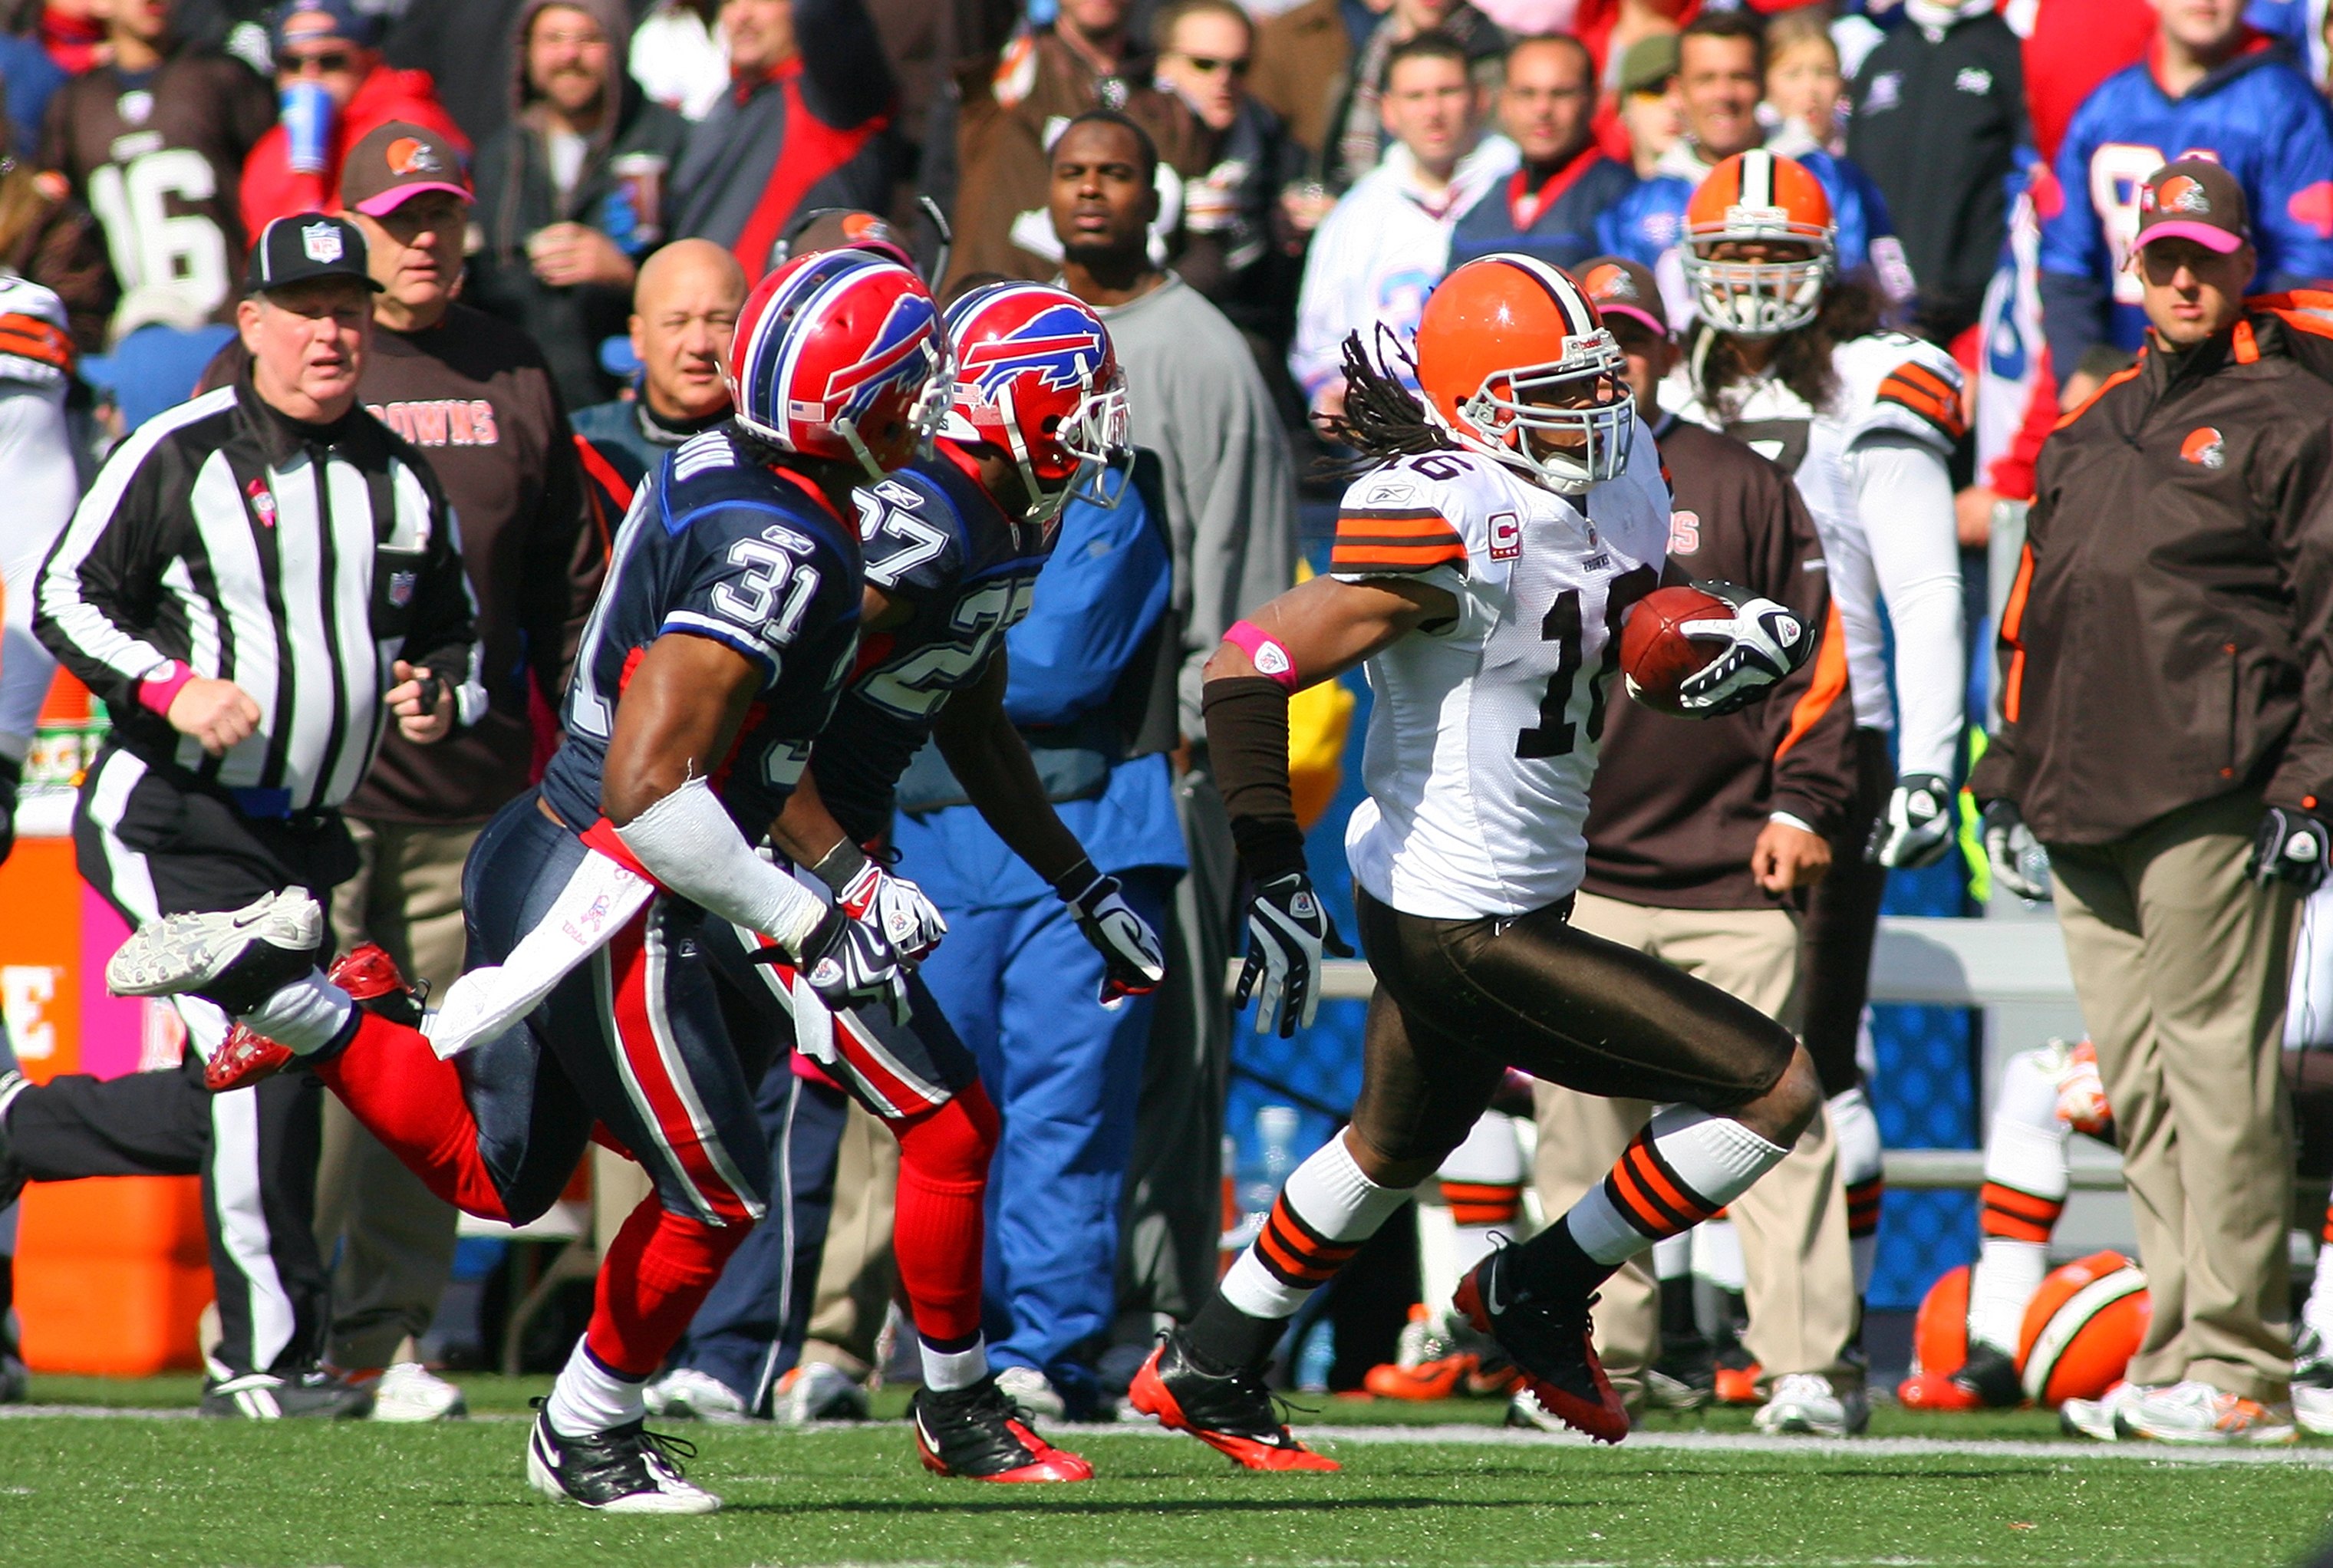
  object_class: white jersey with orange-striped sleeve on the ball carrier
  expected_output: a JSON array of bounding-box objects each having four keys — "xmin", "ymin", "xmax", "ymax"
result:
[{"xmin": 1330, "ymin": 425, "xmax": 1668, "ymax": 919}]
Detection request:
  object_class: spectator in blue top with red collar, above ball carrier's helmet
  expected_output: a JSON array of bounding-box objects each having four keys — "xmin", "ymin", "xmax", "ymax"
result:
[{"xmin": 1452, "ymin": 33, "xmax": 1636, "ymax": 266}]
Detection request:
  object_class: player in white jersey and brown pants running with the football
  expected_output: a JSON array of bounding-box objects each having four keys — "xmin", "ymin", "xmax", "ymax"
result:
[{"xmin": 1132, "ymin": 257, "xmax": 1822, "ymax": 1470}]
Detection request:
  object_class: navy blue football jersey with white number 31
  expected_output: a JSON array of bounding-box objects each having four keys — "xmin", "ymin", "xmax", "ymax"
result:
[{"xmin": 544, "ymin": 425, "xmax": 863, "ymax": 842}]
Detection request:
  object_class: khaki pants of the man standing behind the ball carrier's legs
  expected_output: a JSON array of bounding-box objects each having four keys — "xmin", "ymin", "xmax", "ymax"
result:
[{"xmin": 1533, "ymin": 894, "xmax": 1862, "ymax": 1400}]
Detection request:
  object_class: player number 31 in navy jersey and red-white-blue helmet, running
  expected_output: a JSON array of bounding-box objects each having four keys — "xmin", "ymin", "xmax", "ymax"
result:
[{"xmin": 107, "ymin": 252, "xmax": 950, "ymax": 1514}]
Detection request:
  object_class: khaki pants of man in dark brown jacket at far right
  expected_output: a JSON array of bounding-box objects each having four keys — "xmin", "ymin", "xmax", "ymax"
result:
[{"xmin": 2048, "ymin": 793, "xmax": 2298, "ymax": 1400}]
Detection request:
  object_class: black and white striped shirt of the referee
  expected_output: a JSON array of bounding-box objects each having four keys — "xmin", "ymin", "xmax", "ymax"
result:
[{"xmin": 33, "ymin": 374, "xmax": 486, "ymax": 815}]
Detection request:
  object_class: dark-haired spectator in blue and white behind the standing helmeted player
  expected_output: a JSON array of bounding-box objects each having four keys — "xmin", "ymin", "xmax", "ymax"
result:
[{"xmin": 1596, "ymin": 12, "xmax": 1913, "ymax": 322}]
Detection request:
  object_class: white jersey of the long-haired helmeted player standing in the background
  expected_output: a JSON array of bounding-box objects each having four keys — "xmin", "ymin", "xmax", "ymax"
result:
[{"xmin": 1661, "ymin": 331, "xmax": 1965, "ymax": 746}]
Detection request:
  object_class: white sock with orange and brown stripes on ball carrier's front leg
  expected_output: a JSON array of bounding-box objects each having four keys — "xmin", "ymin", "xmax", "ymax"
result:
[{"xmin": 1563, "ymin": 1106, "xmax": 1787, "ymax": 1265}]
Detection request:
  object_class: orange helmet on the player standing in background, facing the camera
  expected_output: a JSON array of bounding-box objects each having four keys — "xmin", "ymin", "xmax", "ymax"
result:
[{"xmin": 1680, "ymin": 147, "xmax": 1838, "ymax": 338}]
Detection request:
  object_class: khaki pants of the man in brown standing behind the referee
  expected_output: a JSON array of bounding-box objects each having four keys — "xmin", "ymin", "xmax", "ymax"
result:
[{"xmin": 315, "ymin": 817, "xmax": 478, "ymax": 1367}]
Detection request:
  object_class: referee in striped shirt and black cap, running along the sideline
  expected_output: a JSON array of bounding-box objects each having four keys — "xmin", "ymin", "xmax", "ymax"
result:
[{"xmin": 0, "ymin": 215, "xmax": 476, "ymax": 1416}]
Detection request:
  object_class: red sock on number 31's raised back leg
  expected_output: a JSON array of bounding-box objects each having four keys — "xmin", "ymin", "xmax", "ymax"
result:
[{"xmin": 315, "ymin": 1008, "xmax": 509, "ymax": 1220}]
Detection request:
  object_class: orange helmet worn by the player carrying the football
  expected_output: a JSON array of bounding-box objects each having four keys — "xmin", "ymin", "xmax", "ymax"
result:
[{"xmin": 1419, "ymin": 255, "xmax": 1636, "ymax": 495}]
